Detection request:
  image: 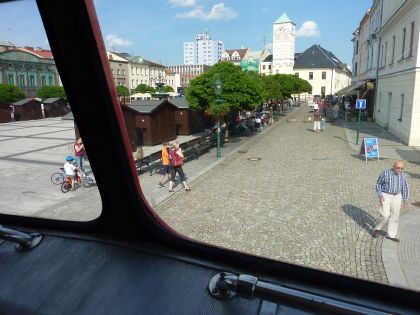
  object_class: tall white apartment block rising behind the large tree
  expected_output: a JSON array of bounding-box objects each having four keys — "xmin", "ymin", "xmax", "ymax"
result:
[{"xmin": 184, "ymin": 31, "xmax": 224, "ymax": 66}]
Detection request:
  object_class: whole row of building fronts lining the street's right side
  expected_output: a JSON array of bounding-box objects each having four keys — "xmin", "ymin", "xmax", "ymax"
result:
[{"xmin": 352, "ymin": 0, "xmax": 420, "ymax": 146}]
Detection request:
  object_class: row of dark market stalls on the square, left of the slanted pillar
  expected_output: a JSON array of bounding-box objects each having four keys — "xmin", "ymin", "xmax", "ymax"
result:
[{"xmin": 0, "ymin": 98, "xmax": 69, "ymax": 123}]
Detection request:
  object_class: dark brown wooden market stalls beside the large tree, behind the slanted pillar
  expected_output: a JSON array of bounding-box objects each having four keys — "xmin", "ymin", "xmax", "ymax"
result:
[{"xmin": 63, "ymin": 98, "xmax": 213, "ymax": 152}]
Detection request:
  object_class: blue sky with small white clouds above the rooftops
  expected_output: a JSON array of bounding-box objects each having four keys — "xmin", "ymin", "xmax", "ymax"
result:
[{"xmin": 0, "ymin": 0, "xmax": 372, "ymax": 65}]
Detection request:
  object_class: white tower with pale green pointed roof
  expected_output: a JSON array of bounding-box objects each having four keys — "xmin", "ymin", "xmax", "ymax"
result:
[{"xmin": 271, "ymin": 13, "xmax": 296, "ymax": 74}]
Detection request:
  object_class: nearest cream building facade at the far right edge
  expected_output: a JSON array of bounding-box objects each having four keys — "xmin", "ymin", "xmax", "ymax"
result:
[{"xmin": 375, "ymin": 0, "xmax": 420, "ymax": 146}]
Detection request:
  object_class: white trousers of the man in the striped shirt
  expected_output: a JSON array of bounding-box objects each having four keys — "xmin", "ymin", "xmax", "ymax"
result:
[{"xmin": 375, "ymin": 193, "xmax": 402, "ymax": 238}]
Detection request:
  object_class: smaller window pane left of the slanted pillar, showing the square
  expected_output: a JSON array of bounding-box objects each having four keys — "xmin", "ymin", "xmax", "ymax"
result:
[{"xmin": 0, "ymin": 1, "xmax": 101, "ymax": 221}]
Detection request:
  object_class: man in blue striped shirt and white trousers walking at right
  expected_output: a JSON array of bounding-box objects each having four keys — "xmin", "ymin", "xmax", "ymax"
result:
[{"xmin": 373, "ymin": 161, "xmax": 409, "ymax": 242}]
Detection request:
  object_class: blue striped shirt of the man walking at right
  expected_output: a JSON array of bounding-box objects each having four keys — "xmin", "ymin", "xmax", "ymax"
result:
[{"xmin": 376, "ymin": 169, "xmax": 409, "ymax": 202}]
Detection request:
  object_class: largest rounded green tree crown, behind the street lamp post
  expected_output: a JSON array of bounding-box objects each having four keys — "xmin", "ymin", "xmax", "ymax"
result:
[{"xmin": 185, "ymin": 62, "xmax": 264, "ymax": 114}]
